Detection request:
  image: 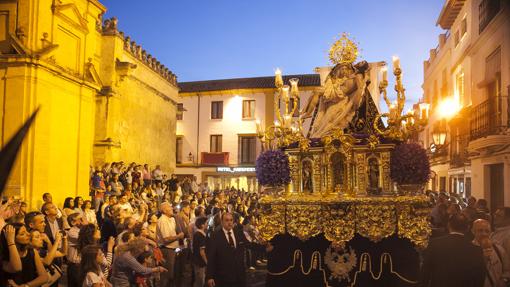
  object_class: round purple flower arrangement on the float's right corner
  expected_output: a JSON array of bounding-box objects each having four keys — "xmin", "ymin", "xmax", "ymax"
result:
[{"xmin": 390, "ymin": 143, "xmax": 430, "ymax": 184}]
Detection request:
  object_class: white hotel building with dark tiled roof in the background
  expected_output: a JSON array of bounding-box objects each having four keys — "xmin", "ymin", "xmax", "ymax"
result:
[{"xmin": 176, "ymin": 74, "xmax": 320, "ymax": 191}]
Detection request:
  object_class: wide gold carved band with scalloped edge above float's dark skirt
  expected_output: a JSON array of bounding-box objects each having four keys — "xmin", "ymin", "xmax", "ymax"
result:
[{"xmin": 259, "ymin": 182, "xmax": 431, "ymax": 248}]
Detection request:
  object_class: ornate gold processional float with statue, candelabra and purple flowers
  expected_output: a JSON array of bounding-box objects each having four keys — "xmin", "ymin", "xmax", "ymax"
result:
[{"xmin": 257, "ymin": 33, "xmax": 431, "ymax": 286}]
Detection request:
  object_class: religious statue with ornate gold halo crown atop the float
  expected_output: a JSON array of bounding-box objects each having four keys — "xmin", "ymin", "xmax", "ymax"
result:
[{"xmin": 301, "ymin": 33, "xmax": 369, "ymax": 138}]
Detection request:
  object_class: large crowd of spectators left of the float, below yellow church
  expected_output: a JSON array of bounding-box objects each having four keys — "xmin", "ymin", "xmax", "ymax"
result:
[{"xmin": 0, "ymin": 162, "xmax": 267, "ymax": 287}]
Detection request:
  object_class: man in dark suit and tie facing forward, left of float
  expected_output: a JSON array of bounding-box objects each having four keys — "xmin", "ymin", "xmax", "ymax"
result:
[{"xmin": 206, "ymin": 212, "xmax": 248, "ymax": 287}]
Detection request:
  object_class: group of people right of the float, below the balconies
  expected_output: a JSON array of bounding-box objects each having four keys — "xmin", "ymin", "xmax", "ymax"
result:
[{"xmin": 421, "ymin": 192, "xmax": 510, "ymax": 287}]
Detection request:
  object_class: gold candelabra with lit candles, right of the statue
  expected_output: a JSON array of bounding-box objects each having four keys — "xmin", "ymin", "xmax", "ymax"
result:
[{"xmin": 374, "ymin": 56, "xmax": 429, "ymax": 141}]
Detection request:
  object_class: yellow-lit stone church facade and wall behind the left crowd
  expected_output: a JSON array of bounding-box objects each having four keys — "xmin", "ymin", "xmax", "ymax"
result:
[{"xmin": 0, "ymin": 0, "xmax": 178, "ymax": 208}]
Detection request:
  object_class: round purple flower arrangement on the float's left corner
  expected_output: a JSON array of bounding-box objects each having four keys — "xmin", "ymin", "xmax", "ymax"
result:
[{"xmin": 256, "ymin": 150, "xmax": 290, "ymax": 187}]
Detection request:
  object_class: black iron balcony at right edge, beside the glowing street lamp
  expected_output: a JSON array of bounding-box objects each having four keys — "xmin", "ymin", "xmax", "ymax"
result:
[{"xmin": 469, "ymin": 96, "xmax": 508, "ymax": 140}]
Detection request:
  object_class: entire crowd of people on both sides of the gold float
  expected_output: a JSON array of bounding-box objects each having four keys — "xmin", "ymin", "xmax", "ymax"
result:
[{"xmin": 0, "ymin": 162, "xmax": 510, "ymax": 287}]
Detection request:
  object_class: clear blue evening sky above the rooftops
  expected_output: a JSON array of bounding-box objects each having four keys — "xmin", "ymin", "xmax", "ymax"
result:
[{"xmin": 101, "ymin": 0, "xmax": 444, "ymax": 102}]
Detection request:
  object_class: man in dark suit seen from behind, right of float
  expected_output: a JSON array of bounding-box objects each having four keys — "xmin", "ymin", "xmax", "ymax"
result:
[{"xmin": 420, "ymin": 214, "xmax": 486, "ymax": 287}]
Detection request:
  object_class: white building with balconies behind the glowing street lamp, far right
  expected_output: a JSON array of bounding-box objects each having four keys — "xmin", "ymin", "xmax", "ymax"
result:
[{"xmin": 420, "ymin": 0, "xmax": 510, "ymax": 208}]
